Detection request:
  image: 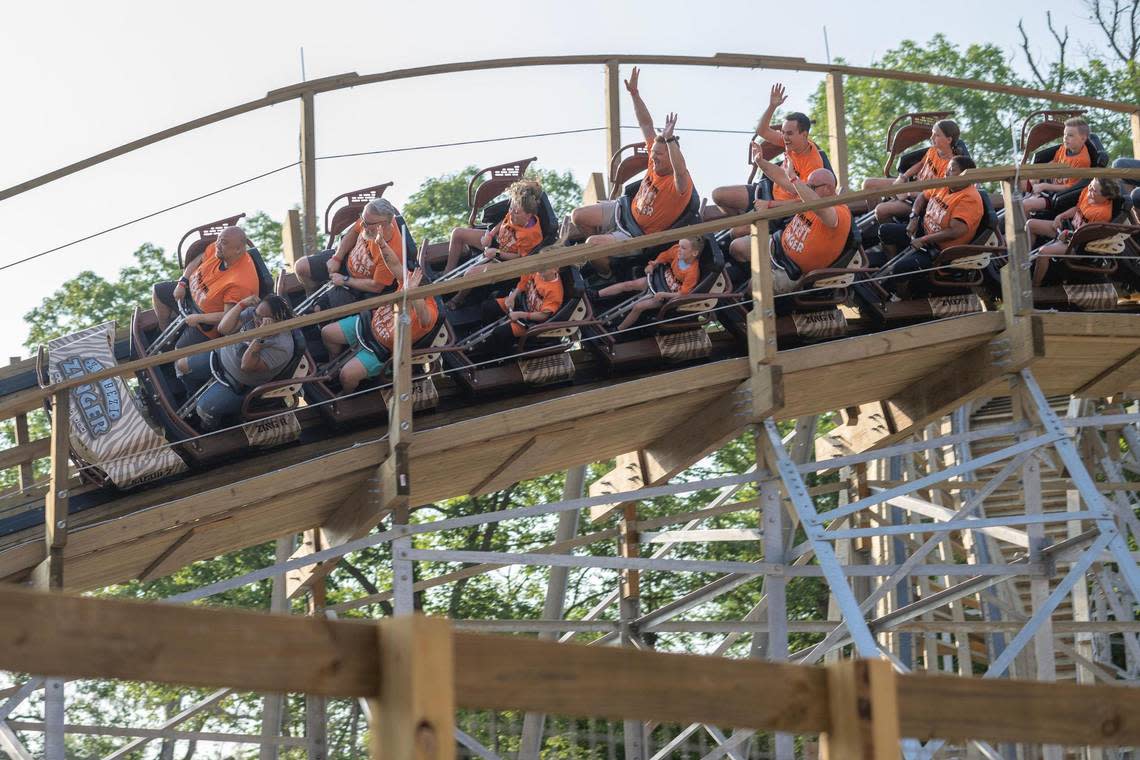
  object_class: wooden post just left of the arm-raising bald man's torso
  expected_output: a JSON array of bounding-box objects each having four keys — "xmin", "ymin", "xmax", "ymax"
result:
[{"xmin": 748, "ymin": 219, "xmax": 783, "ymax": 423}]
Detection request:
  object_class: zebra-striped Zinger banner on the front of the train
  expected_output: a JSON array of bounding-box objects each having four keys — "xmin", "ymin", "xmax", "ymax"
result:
[{"xmin": 47, "ymin": 322, "xmax": 186, "ymax": 489}]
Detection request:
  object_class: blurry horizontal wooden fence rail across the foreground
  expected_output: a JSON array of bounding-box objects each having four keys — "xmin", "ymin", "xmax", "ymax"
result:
[{"xmin": 0, "ymin": 587, "xmax": 1140, "ymax": 757}]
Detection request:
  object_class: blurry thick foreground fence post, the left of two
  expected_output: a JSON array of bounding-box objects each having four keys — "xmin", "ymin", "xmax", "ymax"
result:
[{"xmin": 369, "ymin": 615, "xmax": 455, "ymax": 760}]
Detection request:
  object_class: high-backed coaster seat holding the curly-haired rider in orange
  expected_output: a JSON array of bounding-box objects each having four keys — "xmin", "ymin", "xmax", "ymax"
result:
[{"xmin": 420, "ymin": 156, "xmax": 559, "ymax": 283}]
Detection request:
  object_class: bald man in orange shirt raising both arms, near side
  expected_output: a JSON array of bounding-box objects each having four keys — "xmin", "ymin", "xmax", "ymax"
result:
[{"xmin": 728, "ymin": 158, "xmax": 852, "ymax": 293}]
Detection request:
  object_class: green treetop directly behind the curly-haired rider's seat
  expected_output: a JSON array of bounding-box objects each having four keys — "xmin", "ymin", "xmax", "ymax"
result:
[{"xmin": 402, "ymin": 166, "xmax": 581, "ymax": 243}]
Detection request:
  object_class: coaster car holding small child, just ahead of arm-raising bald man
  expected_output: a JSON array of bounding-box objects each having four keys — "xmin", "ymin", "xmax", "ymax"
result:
[{"xmin": 583, "ymin": 235, "xmax": 739, "ymax": 369}]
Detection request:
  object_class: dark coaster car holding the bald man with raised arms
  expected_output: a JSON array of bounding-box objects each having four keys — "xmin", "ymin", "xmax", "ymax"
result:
[{"xmin": 717, "ymin": 221, "xmax": 873, "ymax": 348}]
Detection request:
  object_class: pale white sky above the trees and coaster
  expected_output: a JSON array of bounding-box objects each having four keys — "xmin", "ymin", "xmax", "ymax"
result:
[{"xmin": 0, "ymin": 0, "xmax": 1100, "ymax": 360}]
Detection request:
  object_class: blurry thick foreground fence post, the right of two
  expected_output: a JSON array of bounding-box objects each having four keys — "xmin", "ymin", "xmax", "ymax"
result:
[{"xmin": 820, "ymin": 660, "xmax": 899, "ymax": 760}]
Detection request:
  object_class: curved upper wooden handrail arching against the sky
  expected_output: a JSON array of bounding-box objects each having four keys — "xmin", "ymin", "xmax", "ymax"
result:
[{"xmin": 0, "ymin": 52, "xmax": 1138, "ymax": 201}]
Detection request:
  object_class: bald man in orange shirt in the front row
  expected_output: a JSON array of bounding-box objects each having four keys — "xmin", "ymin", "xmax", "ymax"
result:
[{"xmin": 150, "ymin": 227, "xmax": 259, "ymax": 348}]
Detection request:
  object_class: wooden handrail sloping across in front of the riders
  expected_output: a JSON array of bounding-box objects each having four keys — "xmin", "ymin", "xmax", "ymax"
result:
[{"xmin": 0, "ymin": 164, "xmax": 1140, "ymax": 419}]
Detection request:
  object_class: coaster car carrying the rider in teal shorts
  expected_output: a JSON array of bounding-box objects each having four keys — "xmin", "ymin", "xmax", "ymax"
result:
[{"xmin": 304, "ymin": 297, "xmax": 455, "ymax": 426}]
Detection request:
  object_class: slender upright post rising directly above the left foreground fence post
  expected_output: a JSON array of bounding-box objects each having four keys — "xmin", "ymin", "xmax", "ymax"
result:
[{"xmin": 381, "ymin": 303, "xmax": 415, "ymax": 619}]
